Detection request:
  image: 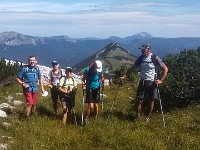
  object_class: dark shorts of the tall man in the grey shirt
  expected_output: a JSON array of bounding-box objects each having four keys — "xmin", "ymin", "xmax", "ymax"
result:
[{"xmin": 137, "ymin": 80, "xmax": 158, "ymax": 100}]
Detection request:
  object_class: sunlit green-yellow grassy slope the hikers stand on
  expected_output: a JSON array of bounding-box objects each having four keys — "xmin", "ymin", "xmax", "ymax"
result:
[{"xmin": 0, "ymin": 84, "xmax": 200, "ymax": 150}]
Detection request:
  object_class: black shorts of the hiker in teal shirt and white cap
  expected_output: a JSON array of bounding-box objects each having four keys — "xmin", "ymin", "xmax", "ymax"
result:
[{"xmin": 85, "ymin": 88, "xmax": 100, "ymax": 103}]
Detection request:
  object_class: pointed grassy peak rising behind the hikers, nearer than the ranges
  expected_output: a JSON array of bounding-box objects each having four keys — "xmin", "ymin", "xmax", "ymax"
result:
[{"xmin": 73, "ymin": 42, "xmax": 136, "ymax": 74}]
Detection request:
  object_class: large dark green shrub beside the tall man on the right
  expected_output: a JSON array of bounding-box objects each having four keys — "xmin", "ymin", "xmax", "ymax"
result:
[{"xmin": 161, "ymin": 47, "xmax": 200, "ymax": 107}]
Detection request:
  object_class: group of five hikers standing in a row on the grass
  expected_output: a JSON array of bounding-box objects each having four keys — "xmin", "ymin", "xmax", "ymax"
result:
[{"xmin": 16, "ymin": 44, "xmax": 168, "ymax": 124}]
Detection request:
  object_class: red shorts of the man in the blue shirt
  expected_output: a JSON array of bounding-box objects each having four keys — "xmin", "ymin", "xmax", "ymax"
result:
[{"xmin": 23, "ymin": 90, "xmax": 38, "ymax": 106}]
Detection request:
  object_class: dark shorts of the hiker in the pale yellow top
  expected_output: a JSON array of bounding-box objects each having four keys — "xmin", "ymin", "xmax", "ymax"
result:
[{"xmin": 61, "ymin": 95, "xmax": 75, "ymax": 109}]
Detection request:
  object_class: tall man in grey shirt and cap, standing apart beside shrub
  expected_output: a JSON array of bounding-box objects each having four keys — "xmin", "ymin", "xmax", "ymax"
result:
[{"xmin": 120, "ymin": 44, "xmax": 168, "ymax": 121}]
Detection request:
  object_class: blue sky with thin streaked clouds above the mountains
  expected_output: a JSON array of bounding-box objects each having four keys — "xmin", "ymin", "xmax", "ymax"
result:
[{"xmin": 0, "ymin": 0, "xmax": 200, "ymax": 38}]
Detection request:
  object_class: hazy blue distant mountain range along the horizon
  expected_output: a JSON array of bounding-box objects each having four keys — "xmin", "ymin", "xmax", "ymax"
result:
[{"xmin": 0, "ymin": 32, "xmax": 200, "ymax": 67}]
